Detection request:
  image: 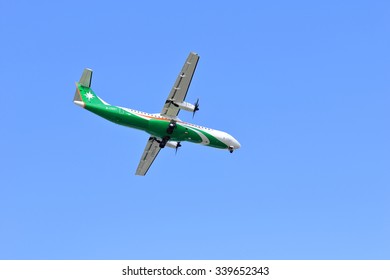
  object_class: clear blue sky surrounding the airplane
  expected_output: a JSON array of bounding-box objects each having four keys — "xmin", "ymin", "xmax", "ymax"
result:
[{"xmin": 0, "ymin": 0, "xmax": 390, "ymax": 259}]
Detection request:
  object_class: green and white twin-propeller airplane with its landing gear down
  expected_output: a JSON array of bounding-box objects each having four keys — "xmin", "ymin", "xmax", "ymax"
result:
[{"xmin": 73, "ymin": 52, "xmax": 241, "ymax": 176}]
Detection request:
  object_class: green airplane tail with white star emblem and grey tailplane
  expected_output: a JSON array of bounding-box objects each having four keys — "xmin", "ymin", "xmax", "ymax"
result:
[{"xmin": 73, "ymin": 68, "xmax": 108, "ymax": 108}]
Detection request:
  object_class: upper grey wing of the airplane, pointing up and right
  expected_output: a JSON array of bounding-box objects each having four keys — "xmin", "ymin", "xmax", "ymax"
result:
[{"xmin": 161, "ymin": 52, "xmax": 199, "ymax": 118}]
